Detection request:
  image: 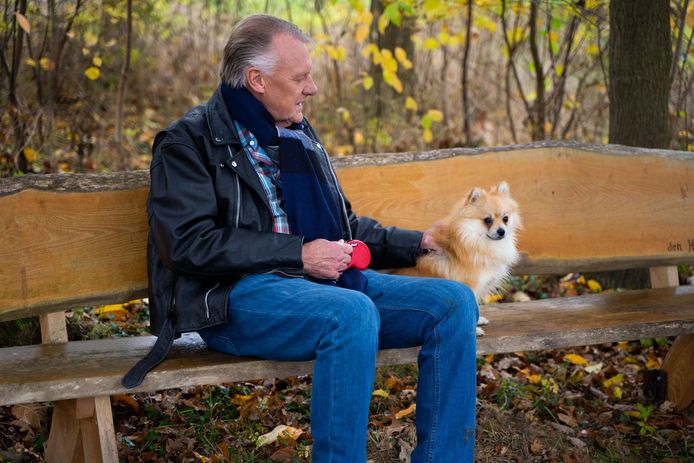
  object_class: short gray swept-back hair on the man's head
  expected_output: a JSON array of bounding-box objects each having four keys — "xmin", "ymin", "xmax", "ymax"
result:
[{"xmin": 219, "ymin": 14, "xmax": 311, "ymax": 88}]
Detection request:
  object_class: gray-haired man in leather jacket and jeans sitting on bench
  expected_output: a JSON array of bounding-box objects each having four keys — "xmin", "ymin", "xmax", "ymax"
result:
[{"xmin": 126, "ymin": 15, "xmax": 478, "ymax": 463}]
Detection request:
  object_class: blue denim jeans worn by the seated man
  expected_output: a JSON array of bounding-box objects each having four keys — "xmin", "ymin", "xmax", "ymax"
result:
[{"xmin": 200, "ymin": 270, "xmax": 478, "ymax": 463}]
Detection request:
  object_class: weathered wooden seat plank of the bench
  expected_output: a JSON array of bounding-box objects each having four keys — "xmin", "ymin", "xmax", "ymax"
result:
[{"xmin": 0, "ymin": 286, "xmax": 694, "ymax": 405}]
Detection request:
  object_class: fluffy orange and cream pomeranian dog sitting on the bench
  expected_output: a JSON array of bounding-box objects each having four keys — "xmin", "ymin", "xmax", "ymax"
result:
[{"xmin": 397, "ymin": 182, "xmax": 522, "ymax": 336}]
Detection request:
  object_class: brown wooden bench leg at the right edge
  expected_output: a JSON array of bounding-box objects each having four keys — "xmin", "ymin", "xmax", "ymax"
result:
[{"xmin": 663, "ymin": 334, "xmax": 694, "ymax": 410}]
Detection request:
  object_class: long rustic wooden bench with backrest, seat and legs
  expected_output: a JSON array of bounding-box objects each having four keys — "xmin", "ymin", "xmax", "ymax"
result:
[{"xmin": 0, "ymin": 143, "xmax": 694, "ymax": 462}]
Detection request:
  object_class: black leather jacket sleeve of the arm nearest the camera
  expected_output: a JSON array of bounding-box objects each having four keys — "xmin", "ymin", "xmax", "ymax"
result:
[{"xmin": 148, "ymin": 135, "xmax": 303, "ymax": 278}]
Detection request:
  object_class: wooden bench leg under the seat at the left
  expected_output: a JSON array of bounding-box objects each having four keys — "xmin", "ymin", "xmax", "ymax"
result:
[{"xmin": 46, "ymin": 396, "xmax": 118, "ymax": 463}]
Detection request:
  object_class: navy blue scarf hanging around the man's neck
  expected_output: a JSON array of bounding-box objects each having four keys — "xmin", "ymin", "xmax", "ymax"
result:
[{"xmin": 221, "ymin": 84, "xmax": 368, "ymax": 292}]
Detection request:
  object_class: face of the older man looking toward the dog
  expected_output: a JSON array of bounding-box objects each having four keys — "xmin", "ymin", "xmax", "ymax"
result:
[{"xmin": 254, "ymin": 34, "xmax": 318, "ymax": 127}]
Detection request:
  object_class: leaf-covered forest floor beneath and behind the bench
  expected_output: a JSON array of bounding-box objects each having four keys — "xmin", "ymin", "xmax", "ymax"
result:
[{"xmin": 0, "ymin": 274, "xmax": 694, "ymax": 463}]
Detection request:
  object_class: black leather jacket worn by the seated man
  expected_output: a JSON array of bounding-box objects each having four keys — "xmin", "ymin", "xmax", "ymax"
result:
[{"xmin": 147, "ymin": 89, "xmax": 422, "ymax": 334}]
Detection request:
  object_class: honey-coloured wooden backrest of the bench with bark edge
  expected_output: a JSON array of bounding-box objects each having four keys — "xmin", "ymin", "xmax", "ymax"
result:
[{"xmin": 0, "ymin": 143, "xmax": 694, "ymax": 321}]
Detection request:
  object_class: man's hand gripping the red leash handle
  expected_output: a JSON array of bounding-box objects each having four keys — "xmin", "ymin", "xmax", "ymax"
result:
[{"xmin": 301, "ymin": 239, "xmax": 353, "ymax": 280}]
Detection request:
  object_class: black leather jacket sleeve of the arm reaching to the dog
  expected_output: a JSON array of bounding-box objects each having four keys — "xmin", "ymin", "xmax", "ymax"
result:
[{"xmin": 345, "ymin": 194, "xmax": 423, "ymax": 270}]
